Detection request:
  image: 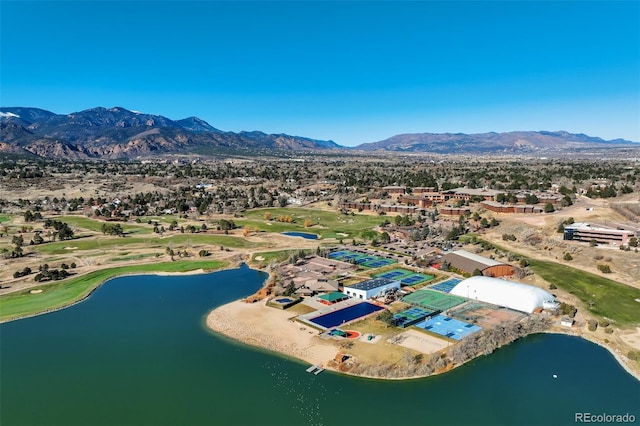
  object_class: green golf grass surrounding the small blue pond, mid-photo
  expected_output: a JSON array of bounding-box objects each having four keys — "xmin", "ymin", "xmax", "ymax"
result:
[{"xmin": 234, "ymin": 207, "xmax": 384, "ymax": 240}]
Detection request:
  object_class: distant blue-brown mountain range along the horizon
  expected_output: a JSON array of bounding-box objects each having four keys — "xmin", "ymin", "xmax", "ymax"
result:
[{"xmin": 0, "ymin": 107, "xmax": 640, "ymax": 159}]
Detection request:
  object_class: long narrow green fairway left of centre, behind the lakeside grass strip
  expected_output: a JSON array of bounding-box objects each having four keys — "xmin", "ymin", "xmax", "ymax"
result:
[{"xmin": 33, "ymin": 234, "xmax": 262, "ymax": 254}]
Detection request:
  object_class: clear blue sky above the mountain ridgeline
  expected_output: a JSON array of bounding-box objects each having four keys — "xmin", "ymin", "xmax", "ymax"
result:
[{"xmin": 0, "ymin": 0, "xmax": 640, "ymax": 146}]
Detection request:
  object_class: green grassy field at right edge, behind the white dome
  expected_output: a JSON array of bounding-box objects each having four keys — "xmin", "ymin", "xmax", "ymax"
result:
[{"xmin": 529, "ymin": 259, "xmax": 640, "ymax": 326}]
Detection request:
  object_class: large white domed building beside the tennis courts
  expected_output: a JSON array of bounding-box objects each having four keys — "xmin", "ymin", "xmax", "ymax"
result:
[{"xmin": 450, "ymin": 276, "xmax": 559, "ymax": 314}]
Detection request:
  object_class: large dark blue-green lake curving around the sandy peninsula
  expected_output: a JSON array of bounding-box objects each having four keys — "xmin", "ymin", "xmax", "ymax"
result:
[{"xmin": 0, "ymin": 266, "xmax": 640, "ymax": 426}]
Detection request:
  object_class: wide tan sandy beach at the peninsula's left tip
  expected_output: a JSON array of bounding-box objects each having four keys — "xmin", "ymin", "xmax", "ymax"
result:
[{"xmin": 207, "ymin": 301, "xmax": 339, "ymax": 367}]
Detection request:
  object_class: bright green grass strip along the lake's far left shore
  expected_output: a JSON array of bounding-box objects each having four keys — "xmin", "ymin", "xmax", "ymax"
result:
[{"xmin": 0, "ymin": 260, "xmax": 227, "ymax": 321}]
